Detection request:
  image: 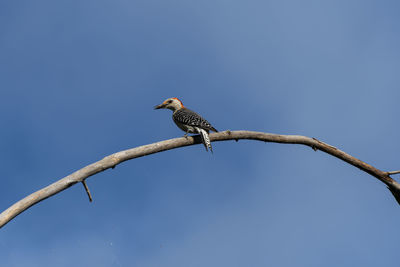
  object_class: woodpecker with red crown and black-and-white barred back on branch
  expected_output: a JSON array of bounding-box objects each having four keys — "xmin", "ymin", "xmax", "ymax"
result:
[{"xmin": 154, "ymin": 97, "xmax": 218, "ymax": 152}]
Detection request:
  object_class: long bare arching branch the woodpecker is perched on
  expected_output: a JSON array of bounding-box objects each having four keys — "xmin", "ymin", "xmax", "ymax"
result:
[{"xmin": 0, "ymin": 131, "xmax": 400, "ymax": 228}]
